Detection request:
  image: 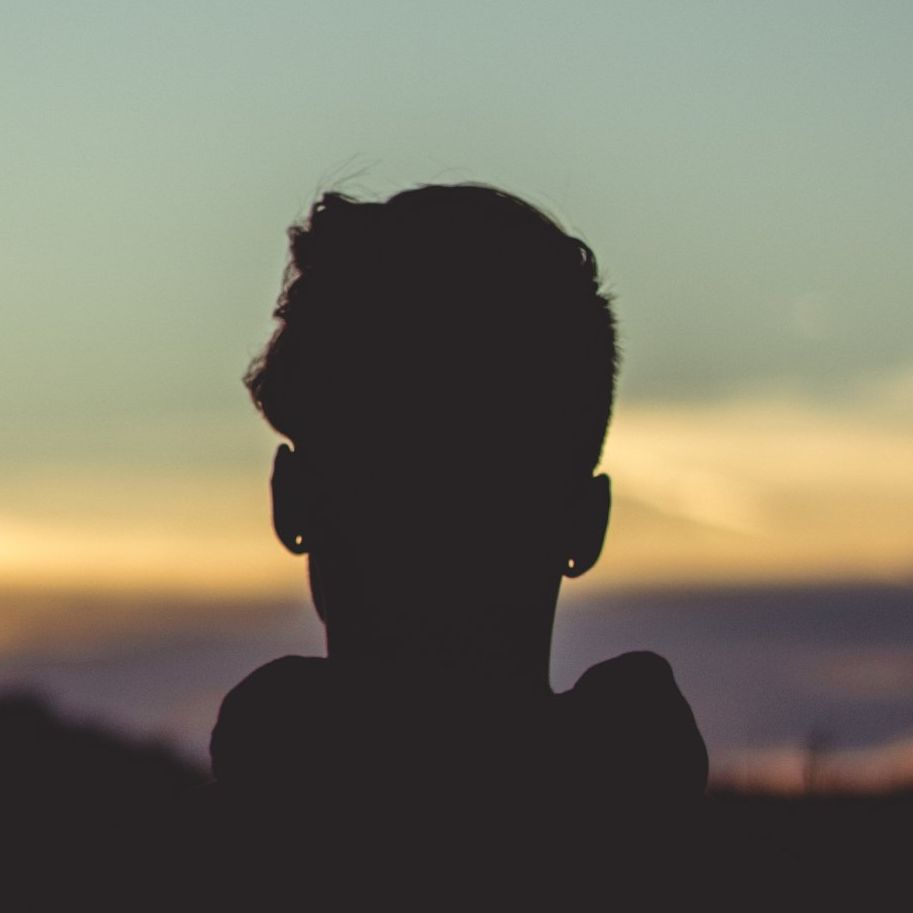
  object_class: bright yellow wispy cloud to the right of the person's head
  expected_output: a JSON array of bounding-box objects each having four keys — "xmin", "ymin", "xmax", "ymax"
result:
[{"xmin": 584, "ymin": 398, "xmax": 913, "ymax": 585}]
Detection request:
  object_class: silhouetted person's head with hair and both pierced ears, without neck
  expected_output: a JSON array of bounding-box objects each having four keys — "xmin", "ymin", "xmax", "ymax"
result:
[{"xmin": 245, "ymin": 185, "xmax": 617, "ymax": 668}]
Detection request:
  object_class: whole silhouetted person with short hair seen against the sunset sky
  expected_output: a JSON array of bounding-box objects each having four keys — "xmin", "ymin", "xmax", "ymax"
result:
[{"xmin": 191, "ymin": 185, "xmax": 707, "ymax": 910}]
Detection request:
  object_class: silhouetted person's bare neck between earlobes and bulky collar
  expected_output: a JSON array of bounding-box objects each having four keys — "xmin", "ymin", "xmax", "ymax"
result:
[{"xmin": 311, "ymin": 555, "xmax": 561, "ymax": 695}]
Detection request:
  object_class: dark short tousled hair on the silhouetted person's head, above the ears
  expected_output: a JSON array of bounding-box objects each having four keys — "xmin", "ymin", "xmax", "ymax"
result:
[{"xmin": 245, "ymin": 184, "xmax": 617, "ymax": 488}]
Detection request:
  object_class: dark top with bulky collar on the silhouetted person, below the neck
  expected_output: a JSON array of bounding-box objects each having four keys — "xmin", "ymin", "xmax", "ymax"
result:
[{"xmin": 182, "ymin": 653, "xmax": 707, "ymax": 910}]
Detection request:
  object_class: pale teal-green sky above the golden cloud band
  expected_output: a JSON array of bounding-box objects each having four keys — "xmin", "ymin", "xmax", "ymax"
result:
[{"xmin": 0, "ymin": 0, "xmax": 913, "ymax": 520}]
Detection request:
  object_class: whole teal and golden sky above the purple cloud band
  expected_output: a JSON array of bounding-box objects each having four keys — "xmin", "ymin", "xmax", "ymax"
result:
[{"xmin": 0, "ymin": 0, "xmax": 913, "ymax": 784}]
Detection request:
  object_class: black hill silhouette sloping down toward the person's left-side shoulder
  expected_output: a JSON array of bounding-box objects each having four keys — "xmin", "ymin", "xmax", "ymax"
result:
[{"xmin": 0, "ymin": 692, "xmax": 206, "ymax": 911}]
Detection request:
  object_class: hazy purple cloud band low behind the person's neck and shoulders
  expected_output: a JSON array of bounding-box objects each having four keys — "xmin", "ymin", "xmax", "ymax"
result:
[{"xmin": 0, "ymin": 583, "xmax": 913, "ymax": 790}]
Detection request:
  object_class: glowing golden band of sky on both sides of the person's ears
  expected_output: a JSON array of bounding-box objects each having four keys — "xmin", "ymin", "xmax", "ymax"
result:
[{"xmin": 0, "ymin": 399, "xmax": 913, "ymax": 616}]
